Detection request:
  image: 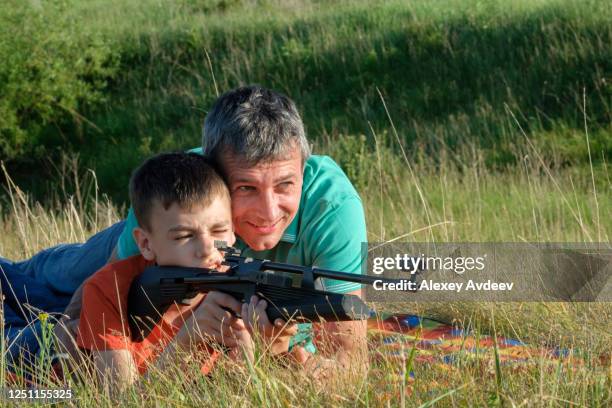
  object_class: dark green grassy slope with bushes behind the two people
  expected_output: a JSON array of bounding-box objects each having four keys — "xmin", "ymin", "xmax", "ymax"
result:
[{"xmin": 0, "ymin": 0, "xmax": 612, "ymax": 201}]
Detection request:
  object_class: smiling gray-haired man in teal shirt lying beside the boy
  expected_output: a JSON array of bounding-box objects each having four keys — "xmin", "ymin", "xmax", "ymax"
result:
[{"xmin": 11, "ymin": 86, "xmax": 366, "ymax": 376}]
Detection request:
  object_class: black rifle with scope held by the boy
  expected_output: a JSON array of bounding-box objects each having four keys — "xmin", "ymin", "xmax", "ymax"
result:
[{"xmin": 128, "ymin": 242, "xmax": 408, "ymax": 341}]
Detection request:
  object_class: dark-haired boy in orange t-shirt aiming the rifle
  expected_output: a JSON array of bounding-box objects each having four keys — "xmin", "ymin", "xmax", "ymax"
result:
[{"xmin": 77, "ymin": 153, "xmax": 289, "ymax": 385}]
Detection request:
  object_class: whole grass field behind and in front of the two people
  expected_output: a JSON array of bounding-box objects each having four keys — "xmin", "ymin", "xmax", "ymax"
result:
[{"xmin": 0, "ymin": 0, "xmax": 612, "ymax": 407}]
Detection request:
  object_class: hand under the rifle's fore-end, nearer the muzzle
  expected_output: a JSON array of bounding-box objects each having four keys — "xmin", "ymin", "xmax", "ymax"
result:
[{"xmin": 241, "ymin": 296, "xmax": 297, "ymax": 355}]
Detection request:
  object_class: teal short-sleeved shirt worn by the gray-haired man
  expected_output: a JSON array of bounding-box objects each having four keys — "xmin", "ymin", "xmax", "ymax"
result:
[{"xmin": 117, "ymin": 148, "xmax": 367, "ymax": 352}]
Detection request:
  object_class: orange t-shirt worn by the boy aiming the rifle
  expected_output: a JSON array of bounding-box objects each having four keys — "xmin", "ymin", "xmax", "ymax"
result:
[{"xmin": 77, "ymin": 255, "xmax": 218, "ymax": 374}]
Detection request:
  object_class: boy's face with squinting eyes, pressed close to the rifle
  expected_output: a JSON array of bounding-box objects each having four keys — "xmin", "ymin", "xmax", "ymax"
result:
[{"xmin": 134, "ymin": 197, "xmax": 236, "ymax": 269}]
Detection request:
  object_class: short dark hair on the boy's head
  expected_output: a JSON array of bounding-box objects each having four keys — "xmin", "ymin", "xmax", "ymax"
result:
[{"xmin": 130, "ymin": 152, "xmax": 229, "ymax": 231}]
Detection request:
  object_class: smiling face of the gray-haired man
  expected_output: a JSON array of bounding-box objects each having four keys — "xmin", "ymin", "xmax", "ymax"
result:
[{"xmin": 221, "ymin": 148, "xmax": 303, "ymax": 251}]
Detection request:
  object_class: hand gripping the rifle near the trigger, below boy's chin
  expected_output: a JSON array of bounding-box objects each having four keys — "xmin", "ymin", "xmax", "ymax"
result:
[{"xmin": 177, "ymin": 292, "xmax": 246, "ymax": 349}]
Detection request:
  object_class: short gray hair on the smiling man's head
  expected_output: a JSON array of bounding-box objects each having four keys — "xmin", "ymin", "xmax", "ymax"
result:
[{"xmin": 202, "ymin": 85, "xmax": 310, "ymax": 166}]
